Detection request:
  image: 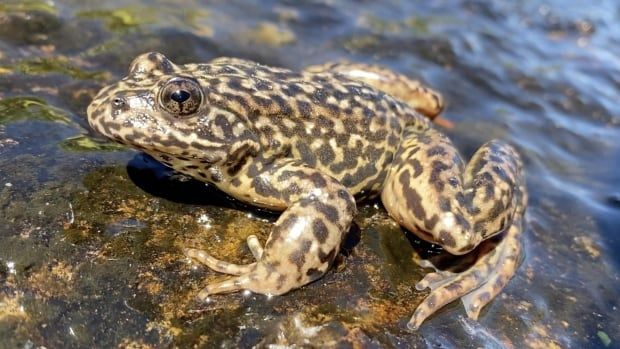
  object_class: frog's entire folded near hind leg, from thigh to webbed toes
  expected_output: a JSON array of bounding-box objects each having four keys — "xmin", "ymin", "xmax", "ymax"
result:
[{"xmin": 381, "ymin": 127, "xmax": 527, "ymax": 329}]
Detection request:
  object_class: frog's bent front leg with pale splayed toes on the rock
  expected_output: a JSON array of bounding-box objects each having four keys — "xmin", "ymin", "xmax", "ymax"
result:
[{"xmin": 186, "ymin": 159, "xmax": 356, "ymax": 300}]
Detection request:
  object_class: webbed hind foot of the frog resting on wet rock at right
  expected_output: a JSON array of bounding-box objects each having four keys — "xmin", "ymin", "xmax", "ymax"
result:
[{"xmin": 407, "ymin": 222, "xmax": 522, "ymax": 330}]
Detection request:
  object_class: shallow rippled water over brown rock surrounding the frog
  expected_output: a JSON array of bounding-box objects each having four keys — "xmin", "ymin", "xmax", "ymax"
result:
[{"xmin": 0, "ymin": 0, "xmax": 620, "ymax": 348}]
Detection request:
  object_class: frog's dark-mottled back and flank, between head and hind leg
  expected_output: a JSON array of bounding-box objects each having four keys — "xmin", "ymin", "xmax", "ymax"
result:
[{"xmin": 201, "ymin": 58, "xmax": 420, "ymax": 196}]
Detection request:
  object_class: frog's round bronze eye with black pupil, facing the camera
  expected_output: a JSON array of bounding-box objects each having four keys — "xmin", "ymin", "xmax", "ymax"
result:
[{"xmin": 158, "ymin": 77, "xmax": 202, "ymax": 116}]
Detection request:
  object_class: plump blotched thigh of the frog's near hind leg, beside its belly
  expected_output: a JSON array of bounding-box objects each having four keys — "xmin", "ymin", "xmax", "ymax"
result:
[{"xmin": 381, "ymin": 127, "xmax": 471, "ymax": 247}]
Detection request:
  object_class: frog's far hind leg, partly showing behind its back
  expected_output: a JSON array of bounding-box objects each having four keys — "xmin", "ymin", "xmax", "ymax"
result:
[{"xmin": 305, "ymin": 62, "xmax": 444, "ymax": 118}]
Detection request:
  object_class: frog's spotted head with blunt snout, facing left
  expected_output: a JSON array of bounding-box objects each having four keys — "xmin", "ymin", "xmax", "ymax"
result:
[{"xmin": 87, "ymin": 52, "xmax": 243, "ymax": 163}]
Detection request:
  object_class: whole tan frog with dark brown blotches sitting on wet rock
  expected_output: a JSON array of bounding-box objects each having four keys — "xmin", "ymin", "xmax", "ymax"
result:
[{"xmin": 87, "ymin": 52, "xmax": 527, "ymax": 330}]
